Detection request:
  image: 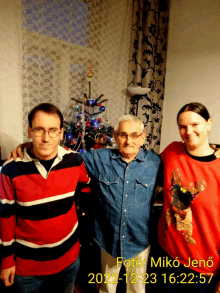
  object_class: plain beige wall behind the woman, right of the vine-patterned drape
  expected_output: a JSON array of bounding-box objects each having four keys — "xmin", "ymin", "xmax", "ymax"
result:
[{"xmin": 160, "ymin": 0, "xmax": 220, "ymax": 151}]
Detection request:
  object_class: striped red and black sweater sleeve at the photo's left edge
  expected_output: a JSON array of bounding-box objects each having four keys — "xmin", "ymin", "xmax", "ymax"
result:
[{"xmin": 0, "ymin": 167, "xmax": 16, "ymax": 269}]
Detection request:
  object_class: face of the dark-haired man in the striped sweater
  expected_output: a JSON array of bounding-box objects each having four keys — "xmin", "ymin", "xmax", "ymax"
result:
[{"xmin": 28, "ymin": 111, "xmax": 63, "ymax": 160}]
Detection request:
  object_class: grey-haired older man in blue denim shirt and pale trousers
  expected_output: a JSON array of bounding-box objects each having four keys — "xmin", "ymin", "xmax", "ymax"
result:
[{"xmin": 6, "ymin": 115, "xmax": 161, "ymax": 293}]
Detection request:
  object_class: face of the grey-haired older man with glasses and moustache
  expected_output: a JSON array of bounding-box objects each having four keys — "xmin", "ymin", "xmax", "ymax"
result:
[{"xmin": 115, "ymin": 121, "xmax": 146, "ymax": 159}]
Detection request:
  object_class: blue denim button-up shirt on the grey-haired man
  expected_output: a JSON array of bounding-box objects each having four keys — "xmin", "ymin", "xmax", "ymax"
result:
[{"xmin": 82, "ymin": 149, "xmax": 161, "ymax": 260}]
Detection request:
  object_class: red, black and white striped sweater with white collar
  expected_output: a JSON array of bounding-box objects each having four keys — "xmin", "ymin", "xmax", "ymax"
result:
[{"xmin": 0, "ymin": 147, "xmax": 89, "ymax": 276}]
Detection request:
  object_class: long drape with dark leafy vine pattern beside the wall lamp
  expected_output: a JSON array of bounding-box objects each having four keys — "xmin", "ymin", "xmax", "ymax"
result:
[{"xmin": 127, "ymin": 0, "xmax": 169, "ymax": 153}]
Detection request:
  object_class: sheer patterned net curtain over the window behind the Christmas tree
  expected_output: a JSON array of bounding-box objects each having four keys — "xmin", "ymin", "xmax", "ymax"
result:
[{"xmin": 22, "ymin": 0, "xmax": 132, "ymax": 140}]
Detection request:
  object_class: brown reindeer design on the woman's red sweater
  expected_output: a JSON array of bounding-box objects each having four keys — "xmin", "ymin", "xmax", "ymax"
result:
[{"xmin": 166, "ymin": 169, "xmax": 206, "ymax": 245}]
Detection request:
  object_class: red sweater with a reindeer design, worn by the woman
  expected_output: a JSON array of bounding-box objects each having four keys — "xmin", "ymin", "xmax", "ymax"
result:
[{"xmin": 159, "ymin": 142, "xmax": 220, "ymax": 274}]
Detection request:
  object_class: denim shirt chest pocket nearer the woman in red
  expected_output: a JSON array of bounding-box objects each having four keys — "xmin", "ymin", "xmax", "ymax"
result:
[{"xmin": 135, "ymin": 177, "xmax": 154, "ymax": 205}]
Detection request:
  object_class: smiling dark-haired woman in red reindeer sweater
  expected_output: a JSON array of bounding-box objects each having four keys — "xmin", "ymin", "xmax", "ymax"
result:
[{"xmin": 155, "ymin": 103, "xmax": 220, "ymax": 293}]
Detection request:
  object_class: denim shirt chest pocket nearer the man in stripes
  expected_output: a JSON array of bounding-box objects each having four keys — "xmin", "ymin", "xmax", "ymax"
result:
[{"xmin": 99, "ymin": 175, "xmax": 119, "ymax": 202}]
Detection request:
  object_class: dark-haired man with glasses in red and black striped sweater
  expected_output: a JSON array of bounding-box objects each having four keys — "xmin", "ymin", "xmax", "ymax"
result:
[{"xmin": 0, "ymin": 103, "xmax": 90, "ymax": 293}]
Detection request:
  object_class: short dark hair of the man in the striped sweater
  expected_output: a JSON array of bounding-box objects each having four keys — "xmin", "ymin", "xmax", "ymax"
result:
[{"xmin": 28, "ymin": 103, "xmax": 63, "ymax": 129}]
